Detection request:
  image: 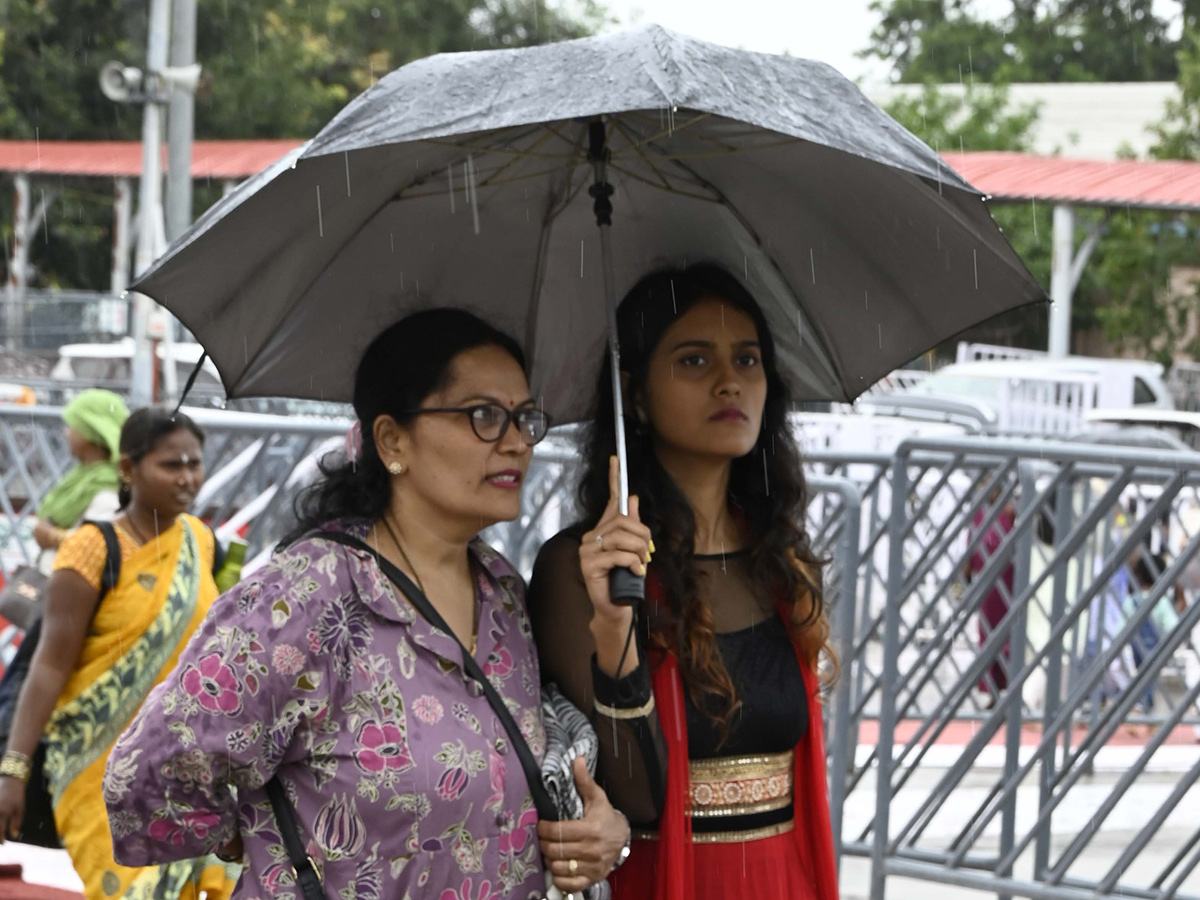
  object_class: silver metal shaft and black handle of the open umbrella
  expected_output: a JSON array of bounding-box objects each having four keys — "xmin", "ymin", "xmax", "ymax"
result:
[{"xmin": 588, "ymin": 119, "xmax": 646, "ymax": 606}]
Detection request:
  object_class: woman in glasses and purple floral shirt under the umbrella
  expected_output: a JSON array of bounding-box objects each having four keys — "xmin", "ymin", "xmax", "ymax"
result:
[{"xmin": 104, "ymin": 308, "xmax": 629, "ymax": 900}]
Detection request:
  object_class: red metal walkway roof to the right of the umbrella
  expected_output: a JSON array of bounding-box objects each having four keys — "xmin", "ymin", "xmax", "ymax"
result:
[{"xmin": 943, "ymin": 152, "xmax": 1200, "ymax": 211}]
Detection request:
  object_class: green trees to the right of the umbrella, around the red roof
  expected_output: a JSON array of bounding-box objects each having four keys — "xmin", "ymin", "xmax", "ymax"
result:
[{"xmin": 865, "ymin": 0, "xmax": 1200, "ymax": 362}]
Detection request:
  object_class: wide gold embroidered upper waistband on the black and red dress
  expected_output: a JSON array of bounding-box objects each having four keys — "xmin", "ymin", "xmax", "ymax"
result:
[{"xmin": 688, "ymin": 750, "xmax": 793, "ymax": 817}]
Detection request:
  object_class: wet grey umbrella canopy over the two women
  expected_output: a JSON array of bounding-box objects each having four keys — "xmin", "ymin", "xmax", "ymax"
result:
[{"xmin": 136, "ymin": 26, "xmax": 1044, "ymax": 422}]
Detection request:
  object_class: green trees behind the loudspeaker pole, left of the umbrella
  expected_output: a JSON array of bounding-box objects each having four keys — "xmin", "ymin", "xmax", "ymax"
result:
[{"xmin": 0, "ymin": 0, "xmax": 606, "ymax": 289}]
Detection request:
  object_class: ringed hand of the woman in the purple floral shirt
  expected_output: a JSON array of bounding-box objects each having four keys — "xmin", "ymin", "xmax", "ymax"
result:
[{"xmin": 538, "ymin": 756, "xmax": 629, "ymax": 894}]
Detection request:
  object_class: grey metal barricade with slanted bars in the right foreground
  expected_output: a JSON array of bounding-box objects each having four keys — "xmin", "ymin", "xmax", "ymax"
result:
[{"xmin": 868, "ymin": 439, "xmax": 1200, "ymax": 900}]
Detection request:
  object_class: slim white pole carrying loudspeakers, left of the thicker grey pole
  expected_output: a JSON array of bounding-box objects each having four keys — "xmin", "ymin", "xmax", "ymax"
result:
[{"xmin": 130, "ymin": 0, "xmax": 170, "ymax": 407}]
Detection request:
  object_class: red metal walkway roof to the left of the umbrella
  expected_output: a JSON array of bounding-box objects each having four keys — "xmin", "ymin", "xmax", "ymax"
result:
[{"xmin": 0, "ymin": 140, "xmax": 301, "ymax": 180}]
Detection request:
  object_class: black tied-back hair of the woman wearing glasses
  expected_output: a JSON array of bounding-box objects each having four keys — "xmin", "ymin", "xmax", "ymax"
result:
[{"xmin": 280, "ymin": 308, "xmax": 526, "ymax": 546}]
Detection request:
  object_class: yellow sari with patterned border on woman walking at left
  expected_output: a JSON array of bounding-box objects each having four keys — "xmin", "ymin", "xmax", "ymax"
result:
[{"xmin": 46, "ymin": 515, "xmax": 239, "ymax": 900}]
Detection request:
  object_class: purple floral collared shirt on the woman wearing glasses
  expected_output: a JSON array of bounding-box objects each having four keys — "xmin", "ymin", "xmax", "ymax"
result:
[{"xmin": 104, "ymin": 522, "xmax": 545, "ymax": 900}]
